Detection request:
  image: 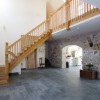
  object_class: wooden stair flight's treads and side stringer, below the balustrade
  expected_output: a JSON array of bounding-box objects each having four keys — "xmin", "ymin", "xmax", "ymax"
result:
[{"xmin": 9, "ymin": 31, "xmax": 51, "ymax": 70}]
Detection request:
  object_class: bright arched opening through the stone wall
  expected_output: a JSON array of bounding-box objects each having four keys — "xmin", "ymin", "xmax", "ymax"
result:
[{"xmin": 62, "ymin": 45, "xmax": 82, "ymax": 69}]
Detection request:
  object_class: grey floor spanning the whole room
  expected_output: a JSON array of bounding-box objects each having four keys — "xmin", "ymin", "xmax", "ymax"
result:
[{"xmin": 0, "ymin": 68, "xmax": 100, "ymax": 100}]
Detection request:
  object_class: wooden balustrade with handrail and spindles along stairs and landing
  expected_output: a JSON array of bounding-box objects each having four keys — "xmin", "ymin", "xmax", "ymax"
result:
[{"xmin": 5, "ymin": 0, "xmax": 100, "ymax": 71}]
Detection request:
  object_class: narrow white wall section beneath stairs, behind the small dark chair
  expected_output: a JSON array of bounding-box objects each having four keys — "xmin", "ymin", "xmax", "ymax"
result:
[{"xmin": 37, "ymin": 43, "xmax": 45, "ymax": 67}]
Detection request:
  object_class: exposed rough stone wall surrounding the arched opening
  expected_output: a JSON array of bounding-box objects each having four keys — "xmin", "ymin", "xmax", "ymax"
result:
[{"xmin": 48, "ymin": 33, "xmax": 100, "ymax": 69}]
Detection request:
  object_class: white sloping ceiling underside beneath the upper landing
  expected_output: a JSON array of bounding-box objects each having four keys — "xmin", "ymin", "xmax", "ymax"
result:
[{"xmin": 49, "ymin": 15, "xmax": 100, "ymax": 41}]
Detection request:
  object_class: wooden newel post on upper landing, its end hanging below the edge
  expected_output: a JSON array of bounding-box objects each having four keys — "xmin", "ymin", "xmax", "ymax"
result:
[{"xmin": 66, "ymin": 0, "xmax": 71, "ymax": 30}]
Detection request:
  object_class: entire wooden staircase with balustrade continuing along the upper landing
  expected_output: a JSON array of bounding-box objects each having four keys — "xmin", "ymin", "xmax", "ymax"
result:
[{"xmin": 0, "ymin": 0, "xmax": 100, "ymax": 83}]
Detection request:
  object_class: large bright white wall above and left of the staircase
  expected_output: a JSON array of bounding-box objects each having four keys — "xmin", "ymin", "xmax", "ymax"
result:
[{"xmin": 0, "ymin": 0, "xmax": 46, "ymax": 65}]
